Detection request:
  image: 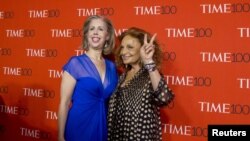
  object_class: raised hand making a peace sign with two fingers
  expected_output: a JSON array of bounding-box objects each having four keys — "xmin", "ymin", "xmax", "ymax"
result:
[{"xmin": 140, "ymin": 33, "xmax": 157, "ymax": 64}]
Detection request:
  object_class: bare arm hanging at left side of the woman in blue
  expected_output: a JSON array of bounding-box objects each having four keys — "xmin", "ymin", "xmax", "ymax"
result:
[{"xmin": 58, "ymin": 71, "xmax": 76, "ymax": 141}]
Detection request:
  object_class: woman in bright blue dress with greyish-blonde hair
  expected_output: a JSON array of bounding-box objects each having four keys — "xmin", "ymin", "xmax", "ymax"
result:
[{"xmin": 58, "ymin": 16, "xmax": 118, "ymax": 141}]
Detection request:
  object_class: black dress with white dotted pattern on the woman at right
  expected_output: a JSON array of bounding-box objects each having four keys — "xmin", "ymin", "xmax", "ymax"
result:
[{"xmin": 108, "ymin": 68, "xmax": 174, "ymax": 141}]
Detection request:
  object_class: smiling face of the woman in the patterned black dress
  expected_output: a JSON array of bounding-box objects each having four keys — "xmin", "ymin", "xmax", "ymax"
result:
[{"xmin": 120, "ymin": 35, "xmax": 141, "ymax": 66}]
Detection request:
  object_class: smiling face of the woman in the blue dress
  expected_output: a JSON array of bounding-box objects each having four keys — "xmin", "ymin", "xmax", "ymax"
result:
[{"xmin": 87, "ymin": 19, "xmax": 109, "ymax": 49}]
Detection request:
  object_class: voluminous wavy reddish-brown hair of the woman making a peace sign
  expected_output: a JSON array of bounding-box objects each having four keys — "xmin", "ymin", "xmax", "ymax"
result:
[{"xmin": 115, "ymin": 27, "xmax": 162, "ymax": 70}]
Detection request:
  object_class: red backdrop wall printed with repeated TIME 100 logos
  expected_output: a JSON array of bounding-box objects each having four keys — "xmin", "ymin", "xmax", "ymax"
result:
[{"xmin": 0, "ymin": 0, "xmax": 250, "ymax": 141}]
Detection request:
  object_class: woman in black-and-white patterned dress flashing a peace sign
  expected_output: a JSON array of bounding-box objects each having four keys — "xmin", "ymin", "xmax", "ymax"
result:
[{"xmin": 108, "ymin": 27, "xmax": 174, "ymax": 141}]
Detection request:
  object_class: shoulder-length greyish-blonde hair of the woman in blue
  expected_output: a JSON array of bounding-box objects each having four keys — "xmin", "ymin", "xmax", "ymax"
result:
[{"xmin": 82, "ymin": 15, "xmax": 115, "ymax": 55}]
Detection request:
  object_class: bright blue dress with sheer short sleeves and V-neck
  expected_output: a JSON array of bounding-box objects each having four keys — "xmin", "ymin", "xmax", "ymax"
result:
[{"xmin": 63, "ymin": 54, "xmax": 118, "ymax": 141}]
